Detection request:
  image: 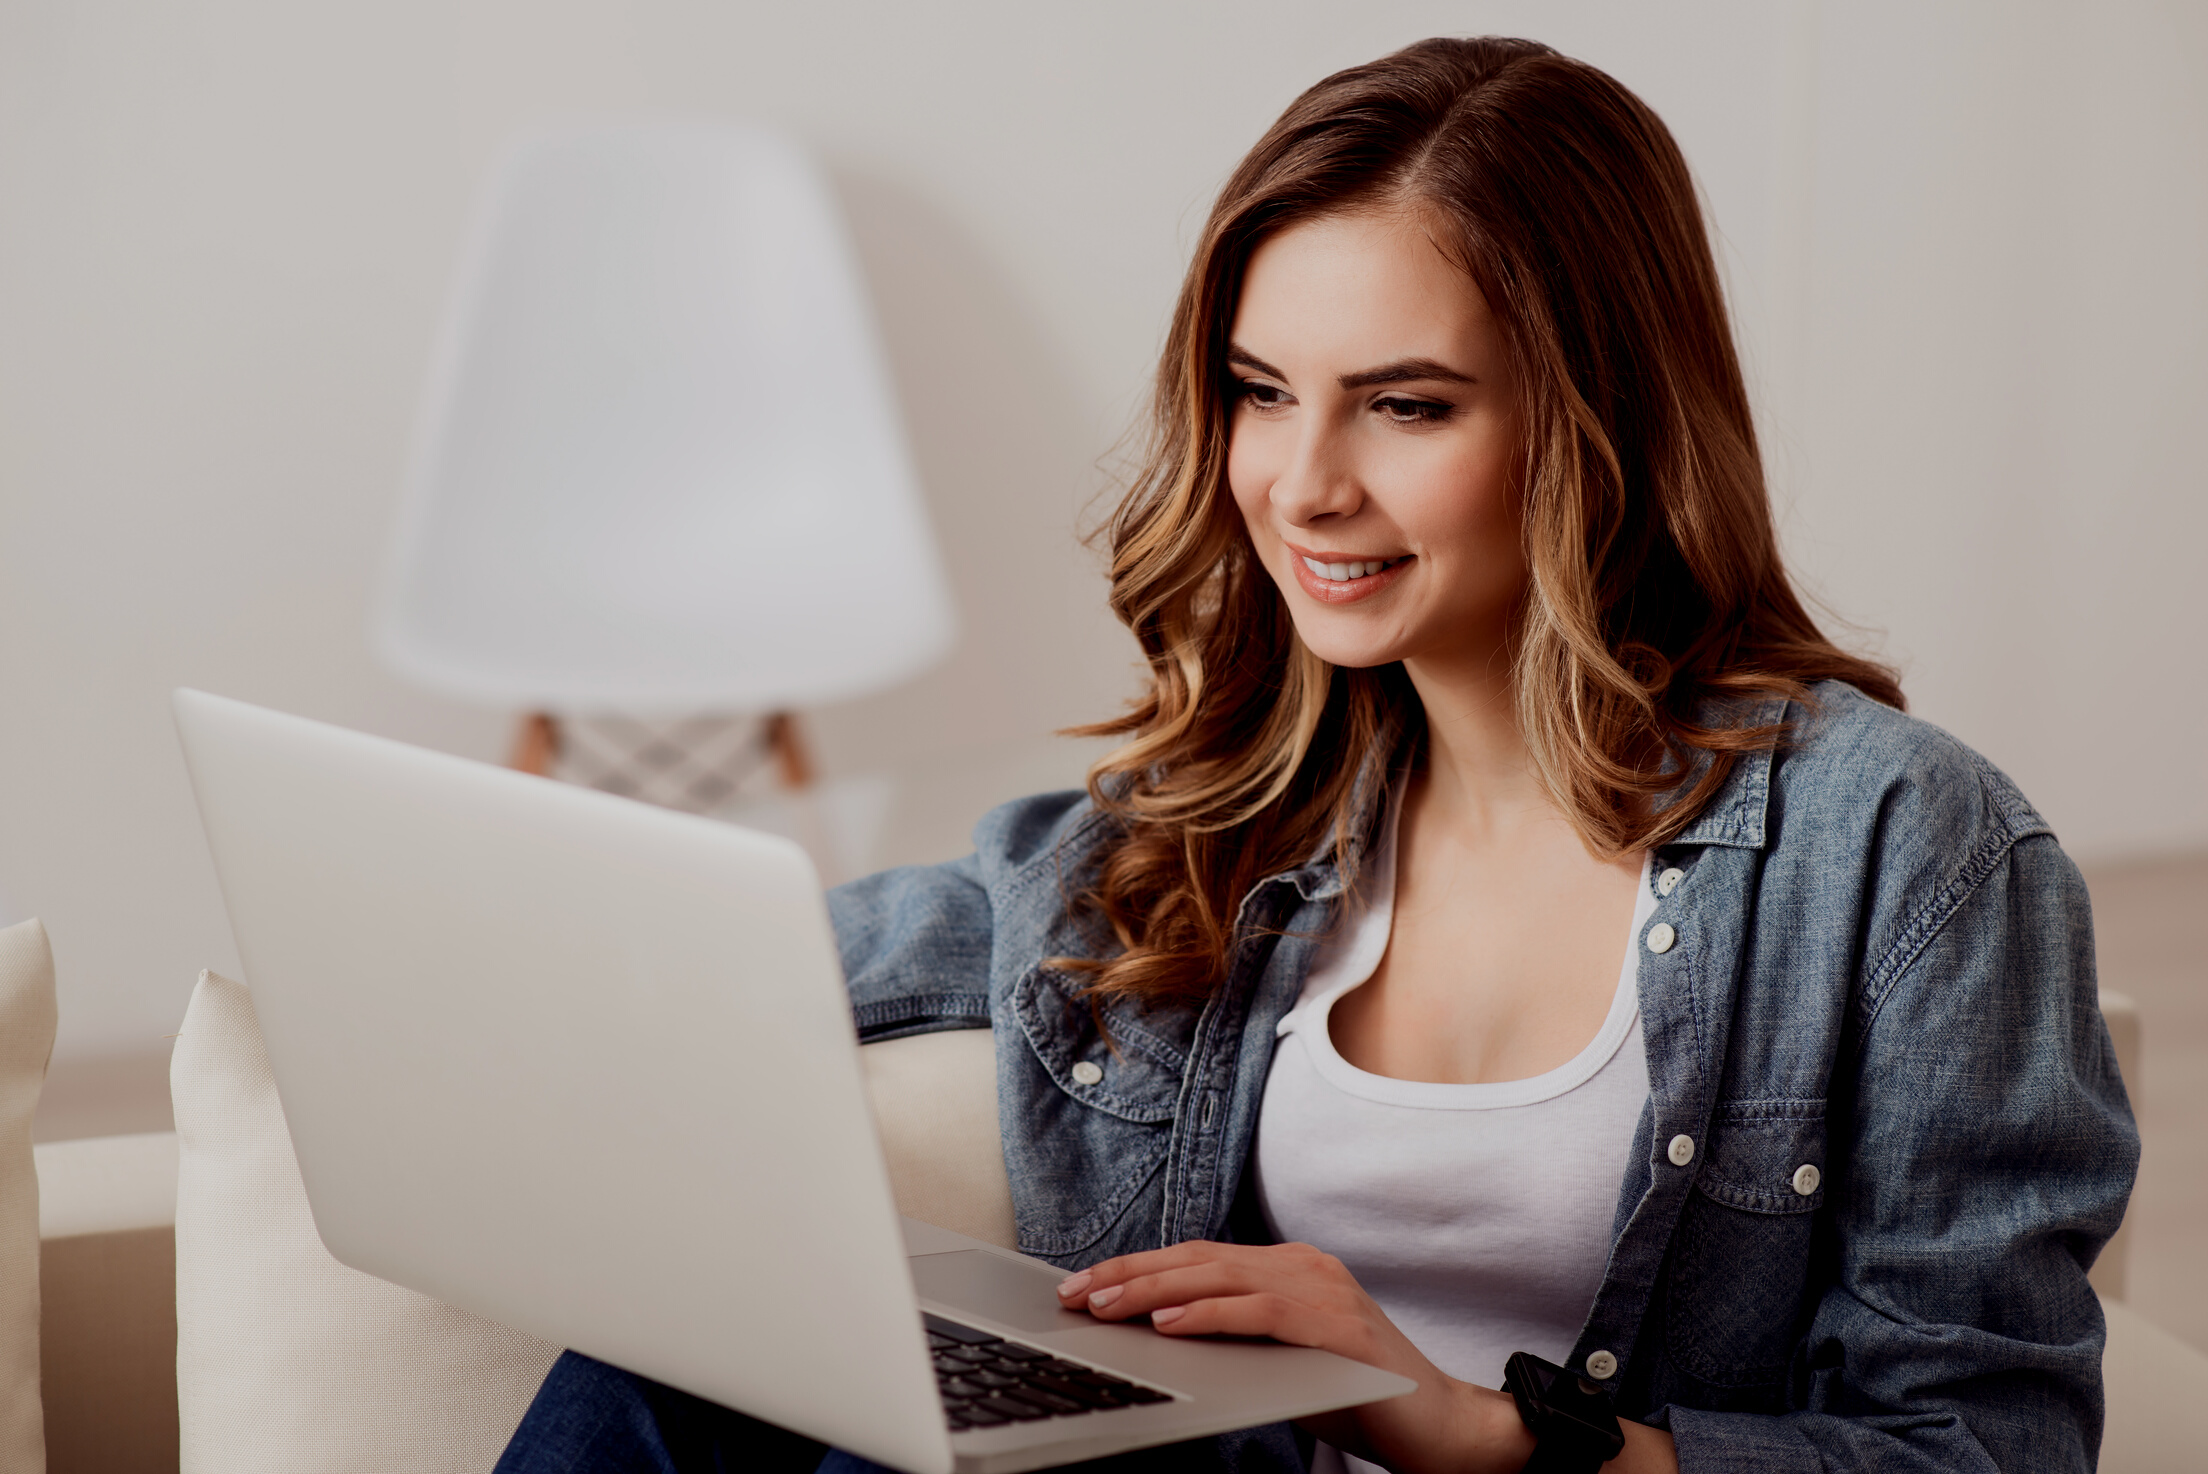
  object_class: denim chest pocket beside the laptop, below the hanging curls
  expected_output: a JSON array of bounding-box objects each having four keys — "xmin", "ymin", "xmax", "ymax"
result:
[{"xmin": 1005, "ymin": 966, "xmax": 1195, "ymax": 1262}]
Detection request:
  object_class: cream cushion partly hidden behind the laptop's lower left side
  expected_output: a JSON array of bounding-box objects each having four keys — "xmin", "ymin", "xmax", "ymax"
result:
[{"xmin": 170, "ymin": 973, "xmax": 559, "ymax": 1474}]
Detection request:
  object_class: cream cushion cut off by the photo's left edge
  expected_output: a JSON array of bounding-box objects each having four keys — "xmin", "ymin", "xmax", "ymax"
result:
[{"xmin": 0, "ymin": 920, "xmax": 53, "ymax": 1474}]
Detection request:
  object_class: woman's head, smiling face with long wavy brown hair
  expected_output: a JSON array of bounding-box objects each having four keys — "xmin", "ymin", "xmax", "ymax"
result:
[{"xmin": 1068, "ymin": 40, "xmax": 1901, "ymax": 1019}]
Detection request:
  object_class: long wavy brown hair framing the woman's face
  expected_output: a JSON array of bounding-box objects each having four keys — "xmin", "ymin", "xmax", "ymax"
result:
[{"xmin": 1080, "ymin": 38, "xmax": 1901, "ymax": 1000}]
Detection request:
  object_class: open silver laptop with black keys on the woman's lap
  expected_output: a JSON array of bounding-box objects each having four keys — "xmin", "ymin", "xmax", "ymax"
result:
[{"xmin": 177, "ymin": 691, "xmax": 1413, "ymax": 1474}]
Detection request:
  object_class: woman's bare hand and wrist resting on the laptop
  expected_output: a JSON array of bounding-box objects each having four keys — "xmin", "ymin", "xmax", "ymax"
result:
[{"xmin": 1058, "ymin": 1240, "xmax": 1678, "ymax": 1474}]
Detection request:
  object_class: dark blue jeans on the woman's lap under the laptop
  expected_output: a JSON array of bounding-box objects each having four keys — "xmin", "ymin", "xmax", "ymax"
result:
[{"xmin": 492, "ymin": 1350, "xmax": 1303, "ymax": 1474}]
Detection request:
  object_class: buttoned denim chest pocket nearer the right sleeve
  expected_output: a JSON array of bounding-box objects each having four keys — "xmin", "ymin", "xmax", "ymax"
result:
[{"xmin": 1665, "ymin": 1099, "xmax": 1826, "ymax": 1390}]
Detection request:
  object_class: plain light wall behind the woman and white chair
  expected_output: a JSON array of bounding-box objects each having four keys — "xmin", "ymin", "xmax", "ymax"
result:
[{"xmin": 0, "ymin": 0, "xmax": 2208, "ymax": 1057}]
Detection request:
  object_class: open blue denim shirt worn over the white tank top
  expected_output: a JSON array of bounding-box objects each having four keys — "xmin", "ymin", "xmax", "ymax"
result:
[{"xmin": 830, "ymin": 684, "xmax": 2140, "ymax": 1472}]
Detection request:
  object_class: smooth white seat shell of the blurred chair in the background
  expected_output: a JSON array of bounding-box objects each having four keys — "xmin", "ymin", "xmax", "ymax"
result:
[{"xmin": 375, "ymin": 124, "xmax": 954, "ymax": 711}]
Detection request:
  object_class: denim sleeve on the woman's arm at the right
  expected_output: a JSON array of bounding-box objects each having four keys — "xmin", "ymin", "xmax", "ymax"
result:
[{"xmin": 1665, "ymin": 832, "xmax": 2140, "ymax": 1474}]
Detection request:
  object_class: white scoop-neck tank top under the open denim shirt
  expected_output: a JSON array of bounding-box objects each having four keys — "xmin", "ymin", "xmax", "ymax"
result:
[{"xmin": 1256, "ymin": 805, "xmax": 1656, "ymax": 1474}]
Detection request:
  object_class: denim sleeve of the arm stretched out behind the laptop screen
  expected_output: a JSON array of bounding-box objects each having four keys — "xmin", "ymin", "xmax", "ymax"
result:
[{"xmin": 828, "ymin": 854, "xmax": 994, "ymax": 1044}]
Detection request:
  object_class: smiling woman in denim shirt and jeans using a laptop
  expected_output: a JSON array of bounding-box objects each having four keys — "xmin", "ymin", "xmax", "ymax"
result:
[{"xmin": 508, "ymin": 40, "xmax": 2137, "ymax": 1470}]
